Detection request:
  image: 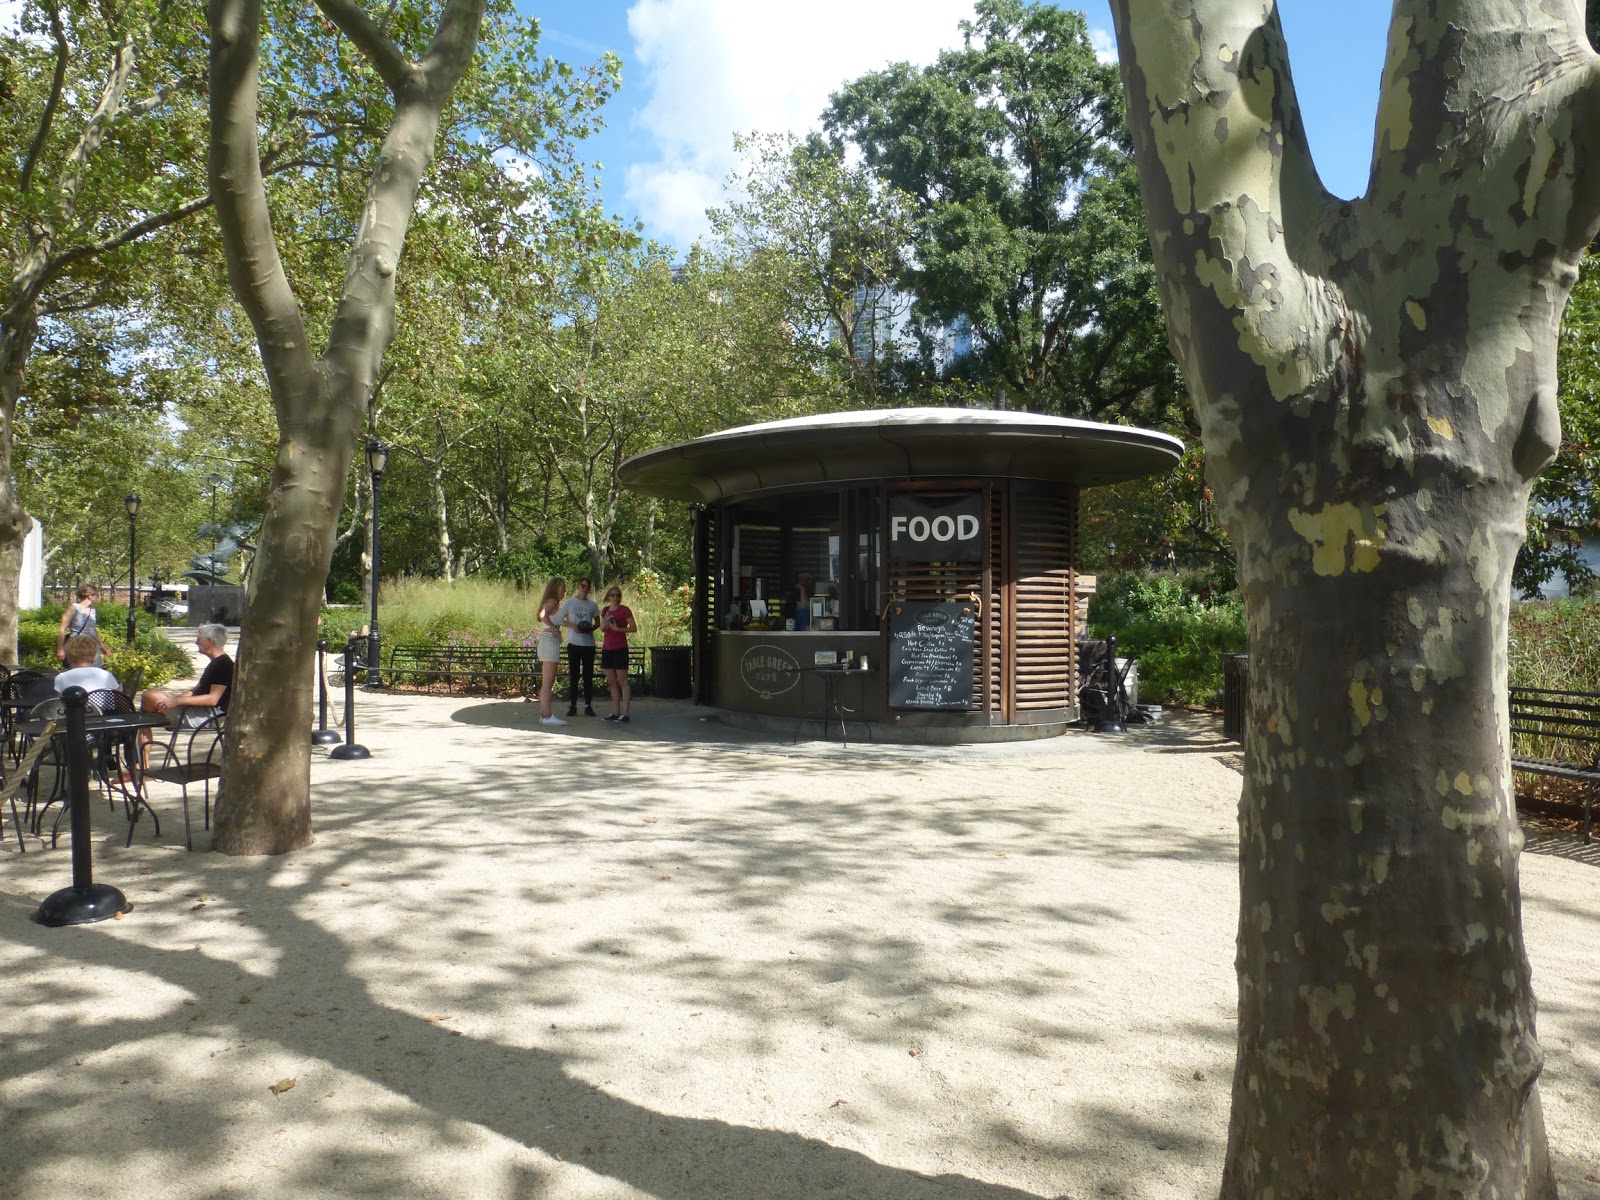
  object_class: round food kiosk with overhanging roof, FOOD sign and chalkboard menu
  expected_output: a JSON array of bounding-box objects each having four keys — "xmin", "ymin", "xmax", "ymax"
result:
[{"xmin": 621, "ymin": 408, "xmax": 1182, "ymax": 742}]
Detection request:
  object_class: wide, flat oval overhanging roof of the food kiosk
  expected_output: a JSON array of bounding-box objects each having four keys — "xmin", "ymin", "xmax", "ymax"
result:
[{"xmin": 619, "ymin": 408, "xmax": 1184, "ymax": 502}]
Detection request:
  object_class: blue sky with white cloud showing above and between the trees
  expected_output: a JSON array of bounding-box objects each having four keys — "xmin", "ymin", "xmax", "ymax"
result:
[{"xmin": 518, "ymin": 0, "xmax": 1390, "ymax": 246}]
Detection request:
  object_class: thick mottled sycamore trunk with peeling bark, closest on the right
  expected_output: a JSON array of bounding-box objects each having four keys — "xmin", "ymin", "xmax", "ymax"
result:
[{"xmin": 1112, "ymin": 0, "xmax": 1600, "ymax": 1200}]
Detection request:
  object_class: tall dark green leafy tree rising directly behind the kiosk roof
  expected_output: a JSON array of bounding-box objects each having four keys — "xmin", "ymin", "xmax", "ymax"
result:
[{"xmin": 824, "ymin": 0, "xmax": 1184, "ymax": 424}]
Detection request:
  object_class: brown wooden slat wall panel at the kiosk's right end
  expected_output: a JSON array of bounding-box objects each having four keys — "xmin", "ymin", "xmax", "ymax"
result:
[{"xmin": 1013, "ymin": 493, "xmax": 1077, "ymax": 710}]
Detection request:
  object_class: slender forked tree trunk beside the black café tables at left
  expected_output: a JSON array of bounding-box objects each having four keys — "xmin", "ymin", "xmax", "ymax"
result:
[{"xmin": 208, "ymin": 0, "xmax": 483, "ymax": 854}]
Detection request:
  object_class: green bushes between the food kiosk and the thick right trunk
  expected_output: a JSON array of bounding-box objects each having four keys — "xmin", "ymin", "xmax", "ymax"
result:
[{"xmin": 1090, "ymin": 573, "xmax": 1245, "ymax": 704}]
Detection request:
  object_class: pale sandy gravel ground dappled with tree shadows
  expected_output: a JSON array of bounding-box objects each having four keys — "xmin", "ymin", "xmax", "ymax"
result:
[{"xmin": 0, "ymin": 696, "xmax": 1600, "ymax": 1200}]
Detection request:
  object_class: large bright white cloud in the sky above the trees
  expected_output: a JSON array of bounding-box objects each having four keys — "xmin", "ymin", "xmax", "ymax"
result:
[{"xmin": 627, "ymin": 0, "xmax": 973, "ymax": 243}]
